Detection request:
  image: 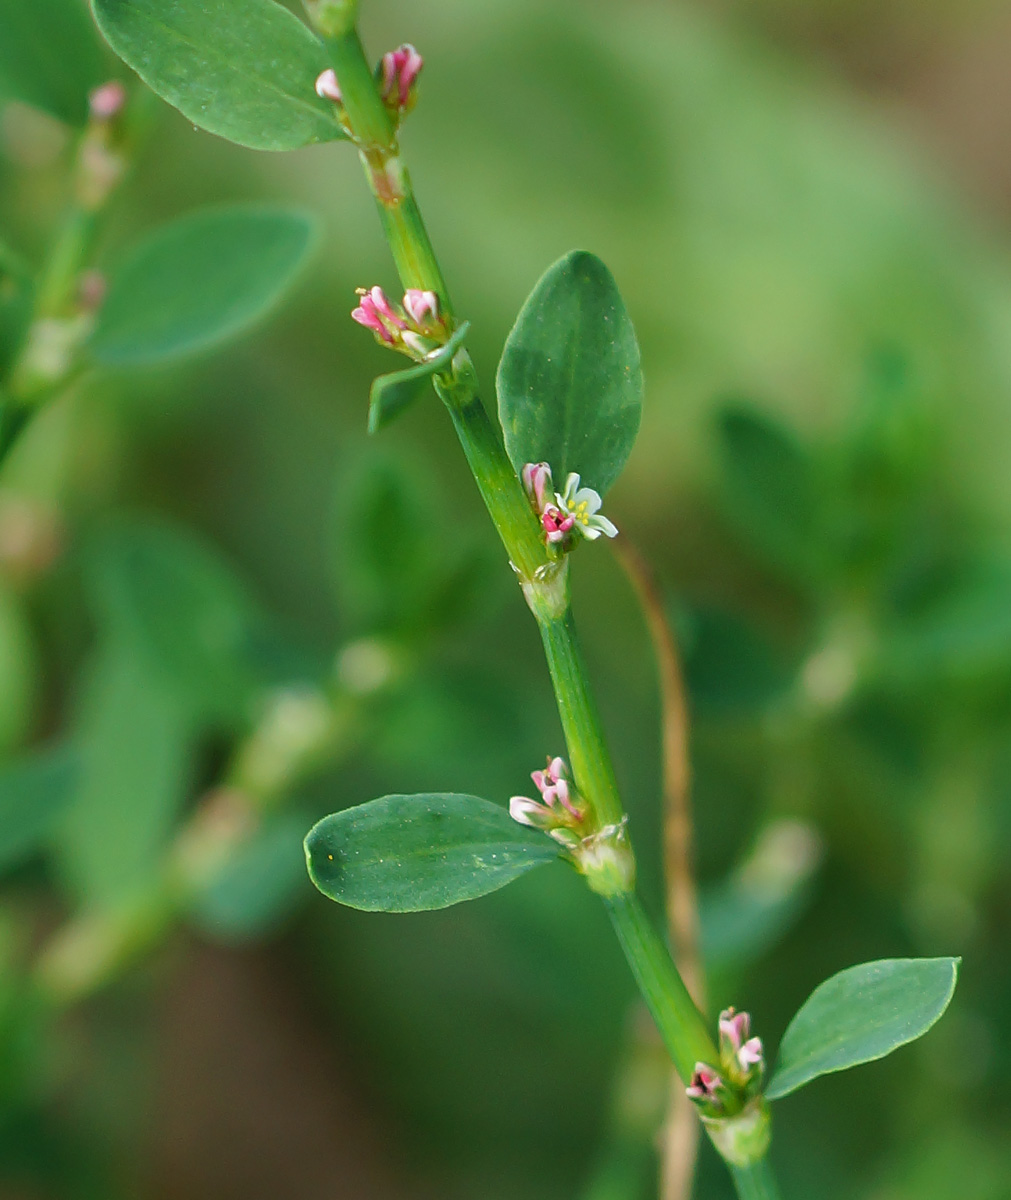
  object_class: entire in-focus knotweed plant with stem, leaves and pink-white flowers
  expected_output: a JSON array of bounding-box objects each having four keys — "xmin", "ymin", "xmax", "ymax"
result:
[{"xmin": 86, "ymin": 0, "xmax": 956, "ymax": 1200}]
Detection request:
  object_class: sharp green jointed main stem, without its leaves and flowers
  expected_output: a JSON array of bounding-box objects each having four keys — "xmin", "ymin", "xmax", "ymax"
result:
[{"xmin": 324, "ymin": 23, "xmax": 774, "ymax": 1200}]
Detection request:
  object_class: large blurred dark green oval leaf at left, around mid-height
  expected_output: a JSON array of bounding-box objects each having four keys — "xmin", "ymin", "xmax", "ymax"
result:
[{"xmin": 84, "ymin": 520, "xmax": 256, "ymax": 722}]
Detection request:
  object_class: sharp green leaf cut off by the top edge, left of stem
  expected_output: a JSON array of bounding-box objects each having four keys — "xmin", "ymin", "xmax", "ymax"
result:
[{"xmin": 87, "ymin": 0, "xmax": 345, "ymax": 150}]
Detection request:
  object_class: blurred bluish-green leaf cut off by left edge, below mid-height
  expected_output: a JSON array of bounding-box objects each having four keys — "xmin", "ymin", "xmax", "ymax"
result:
[{"xmin": 0, "ymin": 746, "xmax": 78, "ymax": 871}]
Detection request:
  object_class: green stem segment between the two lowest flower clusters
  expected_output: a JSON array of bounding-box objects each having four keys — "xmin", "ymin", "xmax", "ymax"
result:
[{"xmin": 604, "ymin": 894, "xmax": 719, "ymax": 1084}]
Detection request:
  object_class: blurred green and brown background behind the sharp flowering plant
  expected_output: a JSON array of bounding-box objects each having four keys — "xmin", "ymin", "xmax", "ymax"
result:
[{"xmin": 0, "ymin": 0, "xmax": 1011, "ymax": 1200}]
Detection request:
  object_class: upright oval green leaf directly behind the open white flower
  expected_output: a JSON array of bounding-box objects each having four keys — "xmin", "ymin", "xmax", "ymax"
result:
[{"xmin": 497, "ymin": 251, "xmax": 642, "ymax": 494}]
